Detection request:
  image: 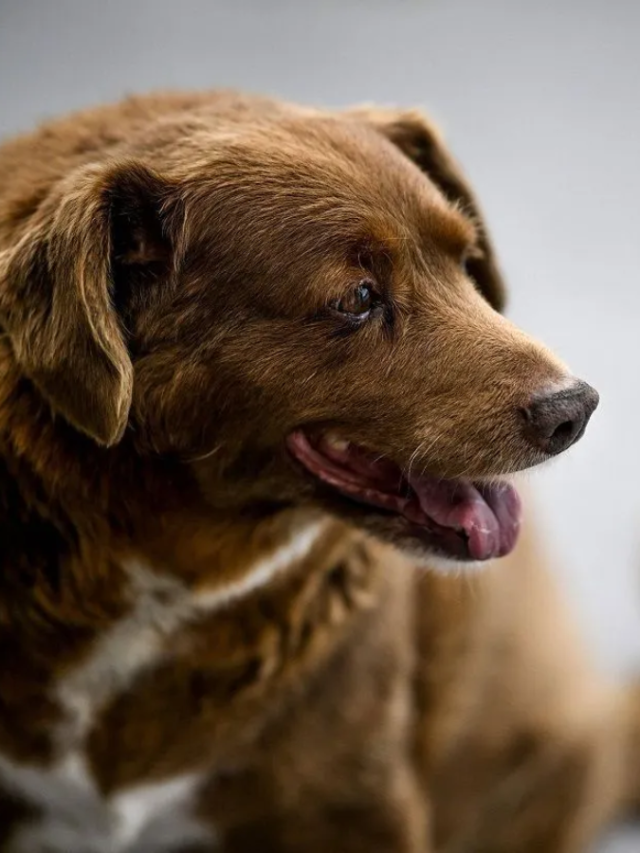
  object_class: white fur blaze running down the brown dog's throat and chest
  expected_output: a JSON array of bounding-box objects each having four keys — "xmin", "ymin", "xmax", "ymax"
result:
[{"xmin": 0, "ymin": 522, "xmax": 324, "ymax": 853}]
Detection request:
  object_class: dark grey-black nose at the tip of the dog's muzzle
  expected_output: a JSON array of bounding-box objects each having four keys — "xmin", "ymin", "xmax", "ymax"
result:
[{"xmin": 522, "ymin": 380, "xmax": 599, "ymax": 456}]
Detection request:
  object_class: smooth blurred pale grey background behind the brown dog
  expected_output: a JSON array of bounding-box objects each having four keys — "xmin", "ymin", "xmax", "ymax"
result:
[{"xmin": 0, "ymin": 0, "xmax": 640, "ymax": 853}]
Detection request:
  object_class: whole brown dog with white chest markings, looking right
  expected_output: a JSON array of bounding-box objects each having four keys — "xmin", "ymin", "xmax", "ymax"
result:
[{"xmin": 0, "ymin": 93, "xmax": 640, "ymax": 853}]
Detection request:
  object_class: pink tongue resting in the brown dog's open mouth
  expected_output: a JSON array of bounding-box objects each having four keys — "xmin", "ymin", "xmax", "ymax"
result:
[{"xmin": 409, "ymin": 477, "xmax": 520, "ymax": 560}]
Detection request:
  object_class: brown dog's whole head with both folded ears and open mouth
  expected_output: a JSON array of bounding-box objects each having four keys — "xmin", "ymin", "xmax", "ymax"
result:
[{"xmin": 2, "ymin": 110, "xmax": 597, "ymax": 560}]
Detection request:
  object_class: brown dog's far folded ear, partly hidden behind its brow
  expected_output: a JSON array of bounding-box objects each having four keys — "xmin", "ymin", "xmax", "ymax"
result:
[{"xmin": 350, "ymin": 107, "xmax": 506, "ymax": 311}]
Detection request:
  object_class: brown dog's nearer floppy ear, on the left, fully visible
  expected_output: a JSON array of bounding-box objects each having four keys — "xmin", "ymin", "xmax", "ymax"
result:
[{"xmin": 0, "ymin": 162, "xmax": 172, "ymax": 446}]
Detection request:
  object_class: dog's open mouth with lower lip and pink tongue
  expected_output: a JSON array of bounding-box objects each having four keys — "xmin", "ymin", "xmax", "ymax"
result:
[{"xmin": 287, "ymin": 430, "xmax": 522, "ymax": 560}]
